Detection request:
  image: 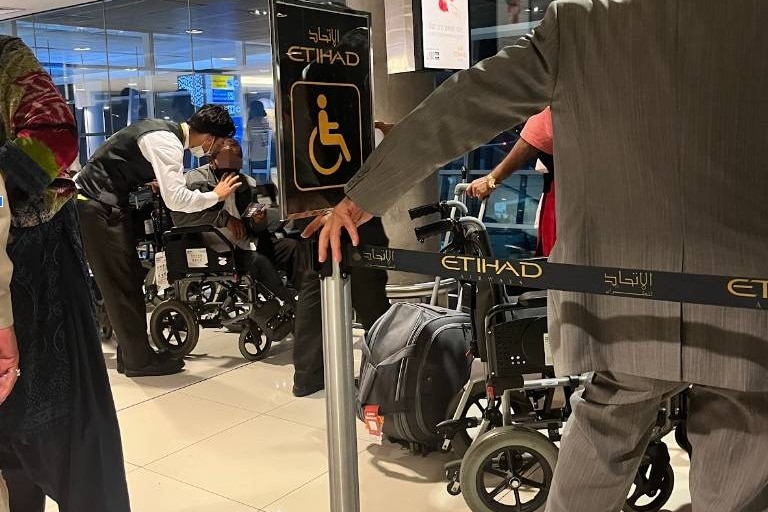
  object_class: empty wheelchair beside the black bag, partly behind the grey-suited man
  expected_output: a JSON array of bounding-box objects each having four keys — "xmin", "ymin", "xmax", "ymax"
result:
[{"xmin": 411, "ymin": 185, "xmax": 691, "ymax": 512}]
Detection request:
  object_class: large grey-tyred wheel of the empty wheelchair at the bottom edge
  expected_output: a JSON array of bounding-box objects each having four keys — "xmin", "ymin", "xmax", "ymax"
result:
[{"xmin": 459, "ymin": 425, "xmax": 557, "ymax": 512}]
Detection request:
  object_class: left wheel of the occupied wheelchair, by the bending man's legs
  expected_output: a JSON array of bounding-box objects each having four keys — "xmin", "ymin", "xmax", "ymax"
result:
[{"xmin": 149, "ymin": 300, "xmax": 200, "ymax": 358}]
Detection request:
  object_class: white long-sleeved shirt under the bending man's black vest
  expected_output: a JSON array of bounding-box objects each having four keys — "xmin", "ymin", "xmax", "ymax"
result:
[{"xmin": 138, "ymin": 125, "xmax": 219, "ymax": 213}]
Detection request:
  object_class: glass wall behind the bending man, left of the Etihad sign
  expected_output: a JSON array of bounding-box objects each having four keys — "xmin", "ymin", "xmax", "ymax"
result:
[{"xmin": 0, "ymin": 0, "xmax": 273, "ymax": 170}]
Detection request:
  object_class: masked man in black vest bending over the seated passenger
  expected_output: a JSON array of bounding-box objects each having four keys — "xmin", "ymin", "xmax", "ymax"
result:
[{"xmin": 75, "ymin": 105, "xmax": 239, "ymax": 377}]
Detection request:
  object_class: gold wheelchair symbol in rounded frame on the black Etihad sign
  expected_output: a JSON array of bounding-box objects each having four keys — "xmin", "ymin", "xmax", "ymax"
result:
[{"xmin": 291, "ymin": 82, "xmax": 363, "ymax": 190}]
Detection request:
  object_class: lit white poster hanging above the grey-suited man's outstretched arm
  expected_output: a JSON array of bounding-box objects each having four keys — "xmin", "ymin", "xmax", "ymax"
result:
[{"xmin": 421, "ymin": 0, "xmax": 470, "ymax": 69}]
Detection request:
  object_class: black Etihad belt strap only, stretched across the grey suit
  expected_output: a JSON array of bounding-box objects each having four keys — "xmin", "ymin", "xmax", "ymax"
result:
[{"xmin": 342, "ymin": 244, "xmax": 768, "ymax": 309}]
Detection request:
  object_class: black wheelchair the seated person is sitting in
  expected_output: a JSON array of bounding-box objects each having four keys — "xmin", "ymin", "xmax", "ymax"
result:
[{"xmin": 150, "ymin": 226, "xmax": 294, "ymax": 361}]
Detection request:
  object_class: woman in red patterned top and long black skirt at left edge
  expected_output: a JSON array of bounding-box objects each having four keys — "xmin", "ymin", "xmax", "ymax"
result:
[{"xmin": 0, "ymin": 36, "xmax": 130, "ymax": 512}]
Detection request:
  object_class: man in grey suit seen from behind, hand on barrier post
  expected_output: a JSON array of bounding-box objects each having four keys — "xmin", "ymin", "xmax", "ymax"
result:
[{"xmin": 306, "ymin": 0, "xmax": 768, "ymax": 512}]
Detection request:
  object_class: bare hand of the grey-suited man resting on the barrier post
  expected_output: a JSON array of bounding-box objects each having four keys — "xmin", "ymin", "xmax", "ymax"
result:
[{"xmin": 301, "ymin": 197, "xmax": 373, "ymax": 263}]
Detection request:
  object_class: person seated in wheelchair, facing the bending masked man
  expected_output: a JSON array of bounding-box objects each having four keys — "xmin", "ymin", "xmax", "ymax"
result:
[{"xmin": 171, "ymin": 139, "xmax": 306, "ymax": 309}]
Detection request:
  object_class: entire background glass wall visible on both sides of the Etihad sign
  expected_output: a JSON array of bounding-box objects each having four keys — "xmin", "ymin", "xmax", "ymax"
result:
[{"xmin": 0, "ymin": 0, "xmax": 551, "ymax": 256}]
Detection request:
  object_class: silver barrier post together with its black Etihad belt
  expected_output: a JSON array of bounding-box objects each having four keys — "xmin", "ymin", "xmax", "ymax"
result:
[{"xmin": 313, "ymin": 241, "xmax": 768, "ymax": 512}]
